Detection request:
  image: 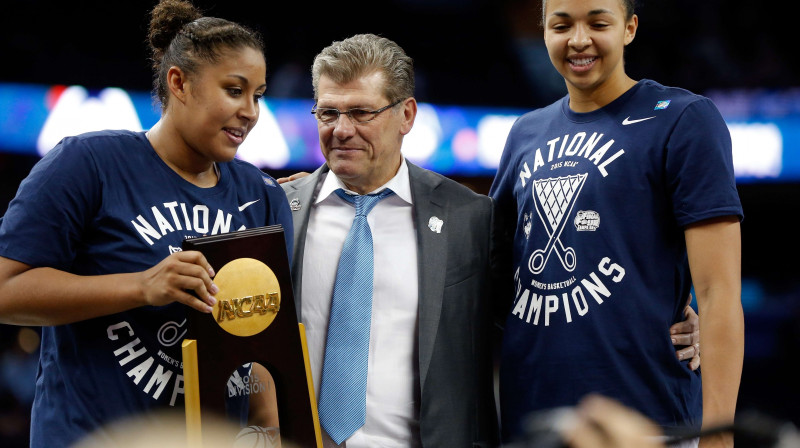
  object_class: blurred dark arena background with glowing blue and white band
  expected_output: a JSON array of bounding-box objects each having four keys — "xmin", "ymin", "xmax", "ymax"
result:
[{"xmin": 0, "ymin": 0, "xmax": 800, "ymax": 447}]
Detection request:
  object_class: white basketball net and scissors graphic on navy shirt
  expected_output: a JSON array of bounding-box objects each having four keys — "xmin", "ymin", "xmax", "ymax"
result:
[{"xmin": 528, "ymin": 174, "xmax": 587, "ymax": 274}]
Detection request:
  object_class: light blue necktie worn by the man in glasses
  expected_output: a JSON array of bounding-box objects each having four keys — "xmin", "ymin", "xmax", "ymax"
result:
[{"xmin": 319, "ymin": 188, "xmax": 393, "ymax": 445}]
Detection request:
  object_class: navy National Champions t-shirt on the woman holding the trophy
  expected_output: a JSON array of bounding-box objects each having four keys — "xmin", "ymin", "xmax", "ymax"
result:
[{"xmin": 0, "ymin": 131, "xmax": 293, "ymax": 448}]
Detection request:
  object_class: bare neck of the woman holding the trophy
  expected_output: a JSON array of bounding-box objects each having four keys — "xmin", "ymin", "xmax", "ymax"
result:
[{"xmin": 145, "ymin": 116, "xmax": 219, "ymax": 188}]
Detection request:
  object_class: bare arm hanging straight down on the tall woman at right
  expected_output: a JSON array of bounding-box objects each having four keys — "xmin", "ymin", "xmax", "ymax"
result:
[{"xmin": 685, "ymin": 216, "xmax": 744, "ymax": 447}]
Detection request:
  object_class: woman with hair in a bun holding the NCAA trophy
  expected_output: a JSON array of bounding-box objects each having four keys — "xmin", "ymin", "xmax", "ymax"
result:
[{"xmin": 0, "ymin": 0, "xmax": 292, "ymax": 448}]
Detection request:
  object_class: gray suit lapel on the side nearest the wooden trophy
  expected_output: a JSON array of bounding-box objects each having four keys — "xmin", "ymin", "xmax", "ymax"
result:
[{"xmin": 283, "ymin": 164, "xmax": 328, "ymax": 322}]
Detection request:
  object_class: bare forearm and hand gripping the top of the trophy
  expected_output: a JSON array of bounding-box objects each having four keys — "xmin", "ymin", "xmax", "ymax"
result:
[{"xmin": 0, "ymin": 251, "xmax": 217, "ymax": 325}]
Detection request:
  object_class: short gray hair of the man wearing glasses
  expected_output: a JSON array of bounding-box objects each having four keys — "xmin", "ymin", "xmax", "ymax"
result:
[{"xmin": 311, "ymin": 34, "xmax": 414, "ymax": 103}]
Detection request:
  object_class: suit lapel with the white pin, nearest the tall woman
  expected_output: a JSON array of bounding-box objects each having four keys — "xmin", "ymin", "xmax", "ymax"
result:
[{"xmin": 408, "ymin": 163, "xmax": 448, "ymax": 388}]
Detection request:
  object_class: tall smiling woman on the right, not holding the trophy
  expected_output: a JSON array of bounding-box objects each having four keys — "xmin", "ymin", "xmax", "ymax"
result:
[{"xmin": 490, "ymin": 0, "xmax": 744, "ymax": 446}]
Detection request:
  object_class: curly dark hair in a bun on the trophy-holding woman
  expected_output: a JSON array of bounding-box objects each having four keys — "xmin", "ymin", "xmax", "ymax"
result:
[{"xmin": 147, "ymin": 0, "xmax": 264, "ymax": 110}]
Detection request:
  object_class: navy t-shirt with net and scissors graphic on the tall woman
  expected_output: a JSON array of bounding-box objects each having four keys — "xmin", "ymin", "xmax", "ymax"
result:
[{"xmin": 490, "ymin": 80, "xmax": 742, "ymax": 439}]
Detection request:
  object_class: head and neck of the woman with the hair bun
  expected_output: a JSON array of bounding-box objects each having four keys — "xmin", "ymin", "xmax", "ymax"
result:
[{"xmin": 147, "ymin": 1, "xmax": 267, "ymax": 187}]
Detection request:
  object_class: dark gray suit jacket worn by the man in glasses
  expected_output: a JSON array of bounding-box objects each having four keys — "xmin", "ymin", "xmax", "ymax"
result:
[{"xmin": 283, "ymin": 163, "xmax": 498, "ymax": 448}]
